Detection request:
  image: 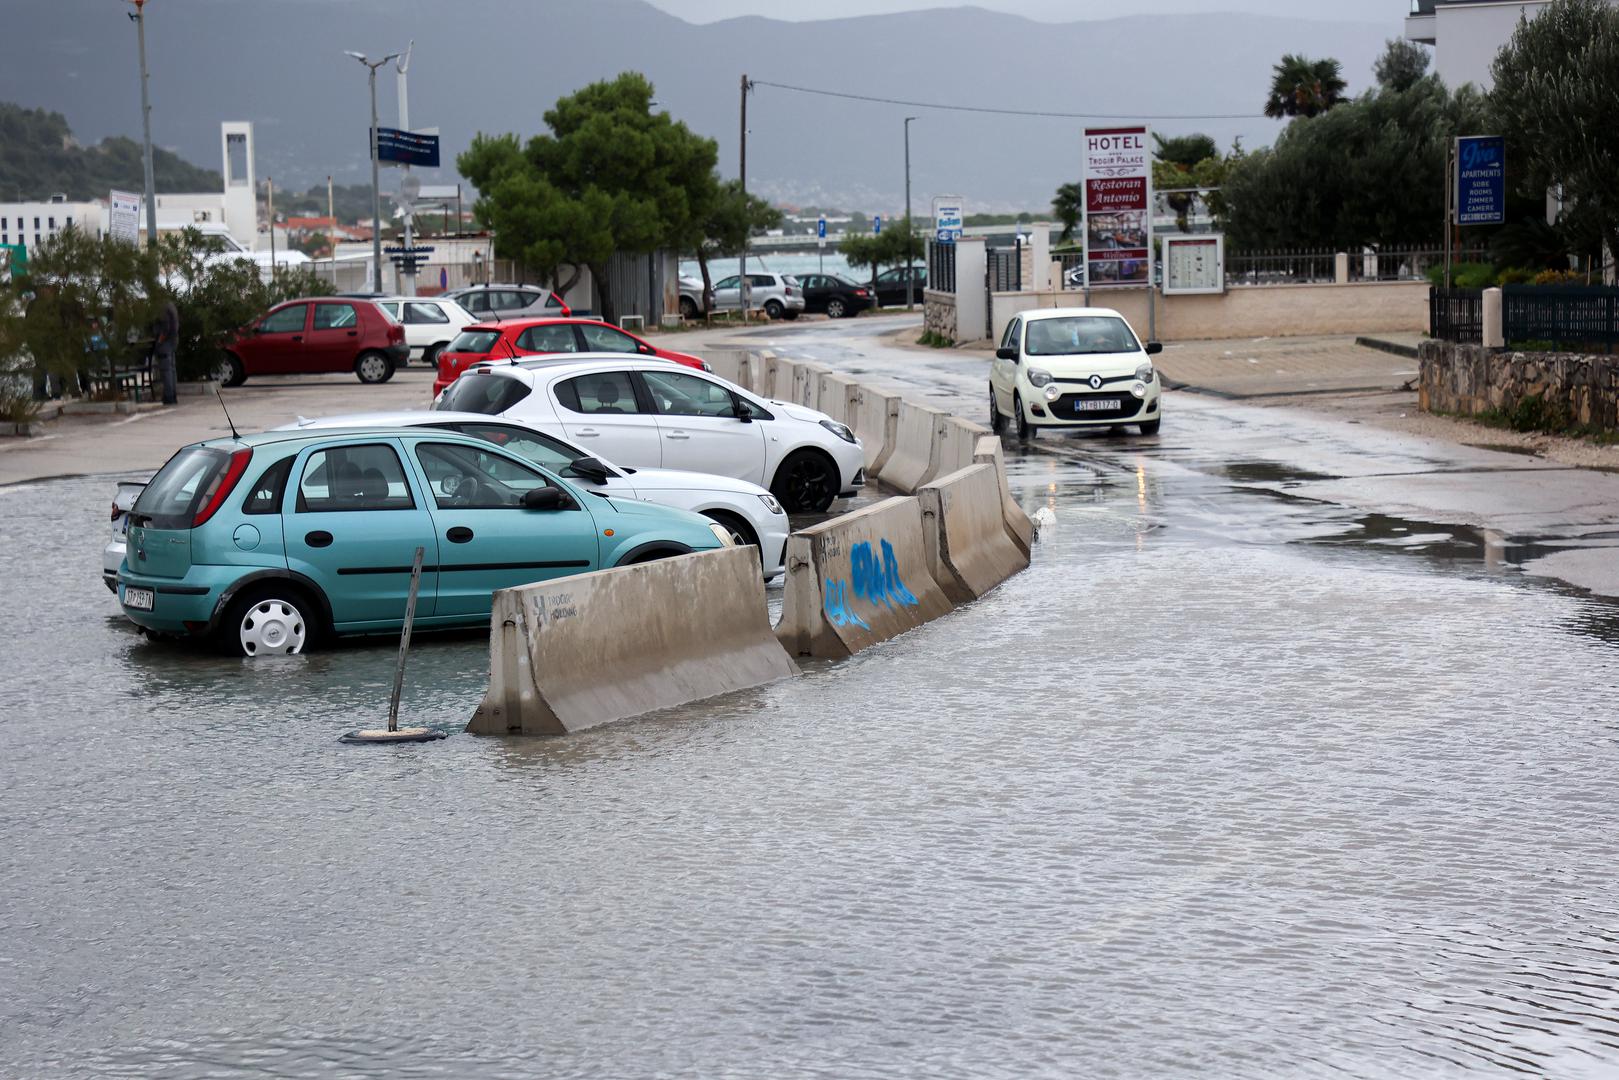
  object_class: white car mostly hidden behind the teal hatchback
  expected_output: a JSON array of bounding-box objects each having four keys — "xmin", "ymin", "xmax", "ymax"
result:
[{"xmin": 280, "ymin": 410, "xmax": 792, "ymax": 576}]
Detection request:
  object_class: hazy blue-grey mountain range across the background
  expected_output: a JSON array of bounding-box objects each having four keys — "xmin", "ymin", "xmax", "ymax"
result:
[{"xmin": 0, "ymin": 0, "xmax": 1400, "ymax": 214}]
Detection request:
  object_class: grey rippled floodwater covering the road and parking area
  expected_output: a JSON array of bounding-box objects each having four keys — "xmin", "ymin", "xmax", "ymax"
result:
[{"xmin": 0, "ymin": 439, "xmax": 1619, "ymax": 1078}]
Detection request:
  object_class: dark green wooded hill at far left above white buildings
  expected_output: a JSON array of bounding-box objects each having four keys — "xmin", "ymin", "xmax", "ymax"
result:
[{"xmin": 0, "ymin": 102, "xmax": 223, "ymax": 202}]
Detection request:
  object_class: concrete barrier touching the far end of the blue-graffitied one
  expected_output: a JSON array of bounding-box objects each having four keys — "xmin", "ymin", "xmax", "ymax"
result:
[{"xmin": 916, "ymin": 465, "xmax": 1028, "ymax": 604}]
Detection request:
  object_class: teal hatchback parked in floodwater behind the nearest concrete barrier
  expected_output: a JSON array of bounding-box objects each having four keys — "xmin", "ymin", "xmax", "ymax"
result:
[{"xmin": 118, "ymin": 427, "xmax": 732, "ymax": 656}]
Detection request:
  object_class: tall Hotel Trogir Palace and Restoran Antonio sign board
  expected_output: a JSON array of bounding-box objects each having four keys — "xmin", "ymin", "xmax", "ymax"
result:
[{"xmin": 1085, "ymin": 126, "xmax": 1153, "ymax": 288}]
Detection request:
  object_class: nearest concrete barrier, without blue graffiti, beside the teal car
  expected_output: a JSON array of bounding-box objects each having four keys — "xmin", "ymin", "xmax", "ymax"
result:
[{"xmin": 466, "ymin": 547, "xmax": 798, "ymax": 735}]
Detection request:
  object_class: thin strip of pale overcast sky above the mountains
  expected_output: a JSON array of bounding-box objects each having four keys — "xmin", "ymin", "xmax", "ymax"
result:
[{"xmin": 651, "ymin": 0, "xmax": 1410, "ymax": 23}]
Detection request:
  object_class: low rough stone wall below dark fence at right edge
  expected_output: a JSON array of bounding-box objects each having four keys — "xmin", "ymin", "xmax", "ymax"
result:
[{"xmin": 1417, "ymin": 342, "xmax": 1619, "ymax": 431}]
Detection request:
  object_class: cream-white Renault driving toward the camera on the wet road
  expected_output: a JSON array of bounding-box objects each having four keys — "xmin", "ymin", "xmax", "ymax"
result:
[{"xmin": 989, "ymin": 308, "xmax": 1164, "ymax": 439}]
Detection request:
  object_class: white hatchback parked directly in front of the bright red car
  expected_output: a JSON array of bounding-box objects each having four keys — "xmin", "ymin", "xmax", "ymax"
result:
[{"xmin": 434, "ymin": 353, "xmax": 866, "ymax": 513}]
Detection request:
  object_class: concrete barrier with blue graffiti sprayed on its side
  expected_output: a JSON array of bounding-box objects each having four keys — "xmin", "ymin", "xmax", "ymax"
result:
[{"xmin": 777, "ymin": 497, "xmax": 952, "ymax": 659}]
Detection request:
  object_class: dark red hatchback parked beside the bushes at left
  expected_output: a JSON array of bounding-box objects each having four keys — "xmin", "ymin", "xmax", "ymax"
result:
[{"xmin": 220, "ymin": 296, "xmax": 410, "ymax": 387}]
